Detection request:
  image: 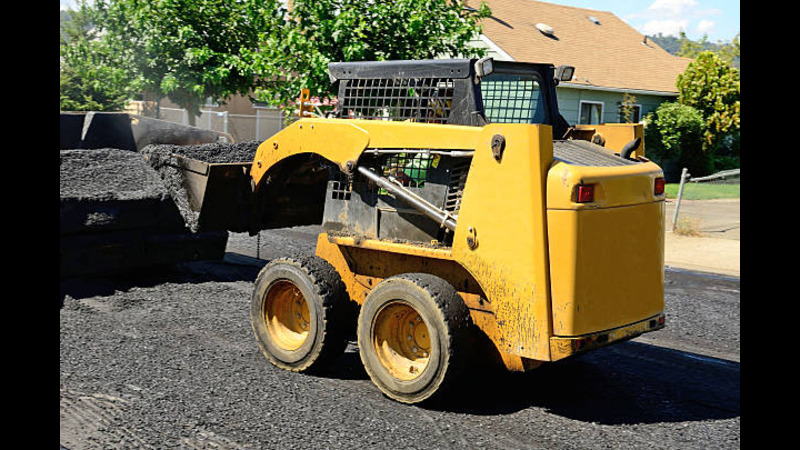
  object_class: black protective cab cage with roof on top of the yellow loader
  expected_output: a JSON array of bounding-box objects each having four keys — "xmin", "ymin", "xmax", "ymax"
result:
[{"xmin": 328, "ymin": 58, "xmax": 569, "ymax": 137}]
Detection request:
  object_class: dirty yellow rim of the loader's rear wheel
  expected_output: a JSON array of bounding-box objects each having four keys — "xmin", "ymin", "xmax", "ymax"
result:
[{"xmin": 372, "ymin": 302, "xmax": 431, "ymax": 381}]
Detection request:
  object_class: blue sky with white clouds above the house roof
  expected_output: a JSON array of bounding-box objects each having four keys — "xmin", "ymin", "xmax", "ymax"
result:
[{"xmin": 59, "ymin": 0, "xmax": 739, "ymax": 42}]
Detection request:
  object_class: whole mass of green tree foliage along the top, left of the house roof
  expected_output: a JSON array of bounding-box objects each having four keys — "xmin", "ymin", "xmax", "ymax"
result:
[{"xmin": 62, "ymin": 0, "xmax": 490, "ymax": 123}]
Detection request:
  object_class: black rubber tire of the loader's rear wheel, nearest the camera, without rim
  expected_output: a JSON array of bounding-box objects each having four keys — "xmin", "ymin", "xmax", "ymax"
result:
[{"xmin": 357, "ymin": 273, "xmax": 472, "ymax": 403}]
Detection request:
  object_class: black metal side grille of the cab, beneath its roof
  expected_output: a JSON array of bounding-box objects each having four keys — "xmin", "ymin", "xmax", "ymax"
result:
[{"xmin": 338, "ymin": 78, "xmax": 453, "ymax": 123}]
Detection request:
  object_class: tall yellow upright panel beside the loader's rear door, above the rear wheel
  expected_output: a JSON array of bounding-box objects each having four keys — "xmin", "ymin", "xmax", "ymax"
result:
[{"xmin": 453, "ymin": 124, "xmax": 553, "ymax": 361}]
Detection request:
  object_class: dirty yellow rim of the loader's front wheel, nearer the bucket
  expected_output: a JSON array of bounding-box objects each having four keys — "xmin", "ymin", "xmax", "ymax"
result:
[{"xmin": 264, "ymin": 280, "xmax": 311, "ymax": 351}]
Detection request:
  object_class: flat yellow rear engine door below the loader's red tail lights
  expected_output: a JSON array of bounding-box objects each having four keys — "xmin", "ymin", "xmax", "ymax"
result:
[{"xmin": 547, "ymin": 202, "xmax": 664, "ymax": 336}]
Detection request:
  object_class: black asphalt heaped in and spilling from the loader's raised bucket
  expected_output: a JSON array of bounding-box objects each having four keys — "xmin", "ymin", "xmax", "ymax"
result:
[{"xmin": 140, "ymin": 141, "xmax": 261, "ymax": 233}]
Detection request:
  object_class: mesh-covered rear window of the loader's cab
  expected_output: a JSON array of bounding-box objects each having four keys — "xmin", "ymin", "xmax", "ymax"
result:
[{"xmin": 480, "ymin": 72, "xmax": 545, "ymax": 123}]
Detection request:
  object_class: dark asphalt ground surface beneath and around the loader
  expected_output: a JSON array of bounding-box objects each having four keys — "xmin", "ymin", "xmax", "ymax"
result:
[{"xmin": 60, "ymin": 227, "xmax": 740, "ymax": 450}]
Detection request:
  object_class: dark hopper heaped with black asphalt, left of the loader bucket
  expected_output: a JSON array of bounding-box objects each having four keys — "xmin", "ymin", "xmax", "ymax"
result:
[{"xmin": 59, "ymin": 148, "xmax": 228, "ymax": 277}]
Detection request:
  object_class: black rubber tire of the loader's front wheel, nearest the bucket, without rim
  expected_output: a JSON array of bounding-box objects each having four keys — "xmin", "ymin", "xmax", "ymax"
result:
[{"xmin": 250, "ymin": 256, "xmax": 354, "ymax": 372}]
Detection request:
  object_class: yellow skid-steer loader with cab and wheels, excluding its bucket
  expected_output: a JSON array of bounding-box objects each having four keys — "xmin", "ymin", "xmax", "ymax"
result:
[{"xmin": 192, "ymin": 58, "xmax": 665, "ymax": 403}]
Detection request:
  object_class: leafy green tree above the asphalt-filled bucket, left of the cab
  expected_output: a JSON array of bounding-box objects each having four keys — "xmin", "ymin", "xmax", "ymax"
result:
[{"xmin": 95, "ymin": 0, "xmax": 280, "ymax": 125}]
